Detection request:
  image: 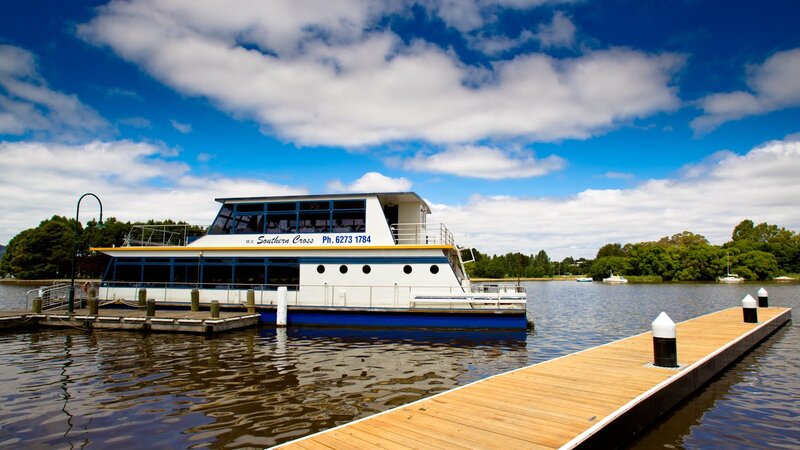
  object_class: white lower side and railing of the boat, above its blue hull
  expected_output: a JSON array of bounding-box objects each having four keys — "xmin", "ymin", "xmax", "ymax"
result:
[{"xmin": 98, "ymin": 281, "xmax": 527, "ymax": 308}]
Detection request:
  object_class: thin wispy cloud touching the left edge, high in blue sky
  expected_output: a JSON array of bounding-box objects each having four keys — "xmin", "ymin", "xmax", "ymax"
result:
[{"xmin": 0, "ymin": 45, "xmax": 110, "ymax": 141}]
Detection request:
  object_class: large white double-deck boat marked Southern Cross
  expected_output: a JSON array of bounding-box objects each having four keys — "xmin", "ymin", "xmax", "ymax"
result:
[{"xmin": 95, "ymin": 192, "xmax": 527, "ymax": 328}]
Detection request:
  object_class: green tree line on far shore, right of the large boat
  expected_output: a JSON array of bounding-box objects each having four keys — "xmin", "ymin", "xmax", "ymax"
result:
[{"xmin": 466, "ymin": 219, "xmax": 800, "ymax": 281}]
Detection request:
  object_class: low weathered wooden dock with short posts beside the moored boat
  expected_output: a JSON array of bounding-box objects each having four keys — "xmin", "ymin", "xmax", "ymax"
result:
[{"xmin": 0, "ymin": 308, "xmax": 260, "ymax": 334}]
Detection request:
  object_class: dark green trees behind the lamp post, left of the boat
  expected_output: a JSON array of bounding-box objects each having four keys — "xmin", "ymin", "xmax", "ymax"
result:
[{"xmin": 0, "ymin": 216, "xmax": 204, "ymax": 280}]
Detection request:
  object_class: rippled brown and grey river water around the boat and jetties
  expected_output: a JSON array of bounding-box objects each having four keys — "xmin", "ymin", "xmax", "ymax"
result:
[{"xmin": 0, "ymin": 282, "xmax": 800, "ymax": 449}]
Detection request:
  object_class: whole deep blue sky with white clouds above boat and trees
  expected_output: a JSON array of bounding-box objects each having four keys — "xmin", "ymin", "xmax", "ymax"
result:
[{"xmin": 0, "ymin": 0, "xmax": 800, "ymax": 259}]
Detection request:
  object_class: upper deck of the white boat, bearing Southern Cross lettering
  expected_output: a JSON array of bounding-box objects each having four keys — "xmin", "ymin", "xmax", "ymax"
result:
[{"xmin": 96, "ymin": 192, "xmax": 455, "ymax": 254}]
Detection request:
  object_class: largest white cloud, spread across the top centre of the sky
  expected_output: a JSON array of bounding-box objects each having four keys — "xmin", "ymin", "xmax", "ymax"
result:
[{"xmin": 79, "ymin": 0, "xmax": 683, "ymax": 147}]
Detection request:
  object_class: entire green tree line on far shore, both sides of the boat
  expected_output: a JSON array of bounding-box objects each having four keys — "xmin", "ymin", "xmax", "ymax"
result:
[{"xmin": 0, "ymin": 216, "xmax": 800, "ymax": 281}]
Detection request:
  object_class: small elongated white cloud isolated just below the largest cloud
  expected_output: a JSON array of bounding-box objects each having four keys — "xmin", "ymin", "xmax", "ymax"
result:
[{"xmin": 402, "ymin": 145, "xmax": 566, "ymax": 180}]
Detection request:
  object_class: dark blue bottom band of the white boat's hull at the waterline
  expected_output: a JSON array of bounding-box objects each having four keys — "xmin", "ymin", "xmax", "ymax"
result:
[{"xmin": 261, "ymin": 310, "xmax": 528, "ymax": 330}]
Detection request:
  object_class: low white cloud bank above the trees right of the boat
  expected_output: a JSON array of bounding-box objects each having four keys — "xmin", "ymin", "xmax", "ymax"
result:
[{"xmin": 429, "ymin": 135, "xmax": 800, "ymax": 259}]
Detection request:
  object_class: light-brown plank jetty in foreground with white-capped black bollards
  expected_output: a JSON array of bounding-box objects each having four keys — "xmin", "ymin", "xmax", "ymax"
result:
[{"xmin": 278, "ymin": 308, "xmax": 791, "ymax": 449}]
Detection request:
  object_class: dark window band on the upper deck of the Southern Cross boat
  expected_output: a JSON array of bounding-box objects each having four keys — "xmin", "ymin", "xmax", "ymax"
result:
[{"xmin": 208, "ymin": 200, "xmax": 366, "ymax": 234}]
